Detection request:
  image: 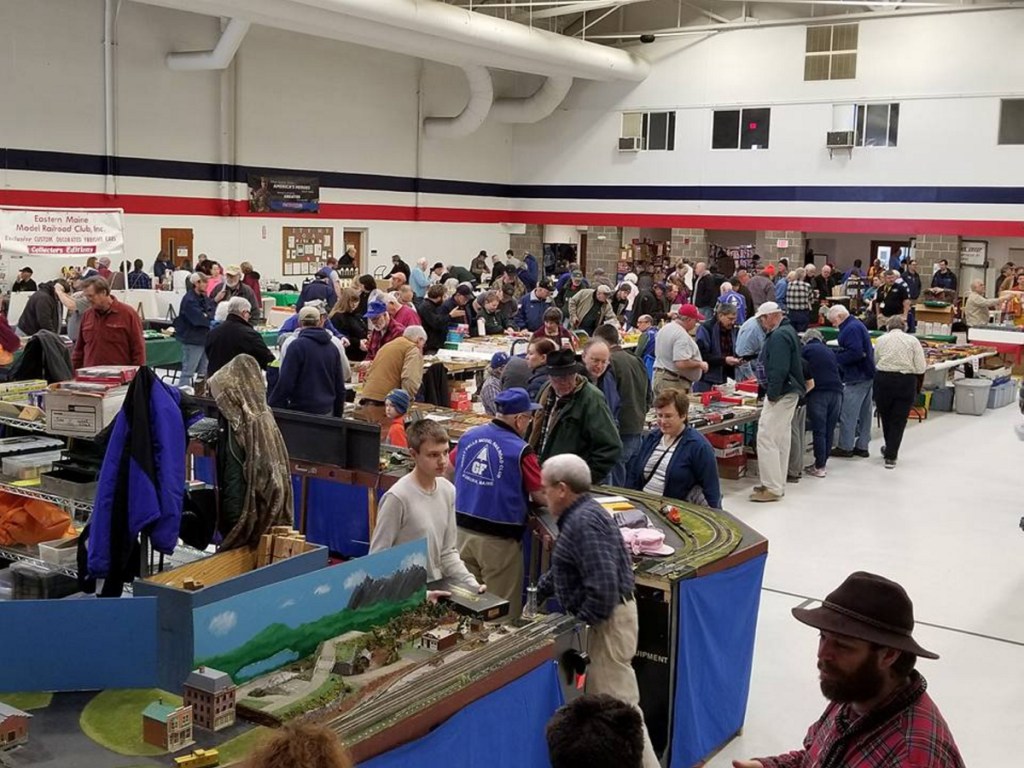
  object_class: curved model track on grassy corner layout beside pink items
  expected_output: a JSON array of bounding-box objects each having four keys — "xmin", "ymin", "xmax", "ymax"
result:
[{"xmin": 617, "ymin": 489, "xmax": 742, "ymax": 579}]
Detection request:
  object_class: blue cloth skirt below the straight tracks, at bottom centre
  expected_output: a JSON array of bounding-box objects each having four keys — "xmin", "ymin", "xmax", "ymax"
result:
[{"xmin": 359, "ymin": 662, "xmax": 563, "ymax": 768}]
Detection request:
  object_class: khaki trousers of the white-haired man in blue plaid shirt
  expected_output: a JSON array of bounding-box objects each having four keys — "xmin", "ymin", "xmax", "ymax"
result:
[{"xmin": 587, "ymin": 600, "xmax": 660, "ymax": 768}]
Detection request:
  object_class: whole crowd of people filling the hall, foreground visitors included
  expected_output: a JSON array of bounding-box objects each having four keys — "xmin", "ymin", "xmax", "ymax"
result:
[{"xmin": 0, "ymin": 246, "xmax": 966, "ymax": 768}]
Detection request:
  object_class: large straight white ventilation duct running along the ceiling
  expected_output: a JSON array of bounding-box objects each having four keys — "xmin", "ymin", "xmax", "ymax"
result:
[{"xmin": 137, "ymin": 0, "xmax": 650, "ymax": 82}]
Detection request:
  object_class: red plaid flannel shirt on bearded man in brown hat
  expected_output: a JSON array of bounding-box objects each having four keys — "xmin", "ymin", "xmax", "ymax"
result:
[{"xmin": 758, "ymin": 671, "xmax": 964, "ymax": 768}]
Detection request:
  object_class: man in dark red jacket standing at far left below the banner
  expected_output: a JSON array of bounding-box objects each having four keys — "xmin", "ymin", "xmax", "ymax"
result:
[{"xmin": 71, "ymin": 276, "xmax": 145, "ymax": 370}]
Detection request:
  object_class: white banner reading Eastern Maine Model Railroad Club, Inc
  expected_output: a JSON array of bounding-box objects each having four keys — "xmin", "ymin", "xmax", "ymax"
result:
[{"xmin": 0, "ymin": 208, "xmax": 125, "ymax": 263}]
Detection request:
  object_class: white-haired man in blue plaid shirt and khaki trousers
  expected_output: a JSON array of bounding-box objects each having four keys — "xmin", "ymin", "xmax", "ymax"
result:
[{"xmin": 537, "ymin": 454, "xmax": 658, "ymax": 768}]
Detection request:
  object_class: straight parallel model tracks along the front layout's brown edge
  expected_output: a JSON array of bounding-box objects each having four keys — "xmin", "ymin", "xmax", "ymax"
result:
[{"xmin": 325, "ymin": 614, "xmax": 575, "ymax": 748}]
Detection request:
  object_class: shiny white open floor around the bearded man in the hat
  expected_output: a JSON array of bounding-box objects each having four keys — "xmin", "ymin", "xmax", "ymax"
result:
[{"xmin": 709, "ymin": 403, "xmax": 1024, "ymax": 768}]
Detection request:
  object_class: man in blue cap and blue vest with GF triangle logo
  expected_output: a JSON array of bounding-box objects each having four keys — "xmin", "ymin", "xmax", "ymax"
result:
[{"xmin": 452, "ymin": 387, "xmax": 544, "ymax": 621}]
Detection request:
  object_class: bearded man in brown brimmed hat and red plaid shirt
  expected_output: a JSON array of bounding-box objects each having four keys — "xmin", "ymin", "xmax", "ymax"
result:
[{"xmin": 732, "ymin": 571, "xmax": 964, "ymax": 768}]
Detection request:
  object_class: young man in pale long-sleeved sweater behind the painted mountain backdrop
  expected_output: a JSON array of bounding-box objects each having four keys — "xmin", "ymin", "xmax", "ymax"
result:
[{"xmin": 370, "ymin": 419, "xmax": 486, "ymax": 593}]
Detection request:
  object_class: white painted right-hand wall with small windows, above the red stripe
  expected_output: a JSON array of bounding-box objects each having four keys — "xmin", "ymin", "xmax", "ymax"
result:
[{"xmin": 513, "ymin": 10, "xmax": 1024, "ymax": 219}]
